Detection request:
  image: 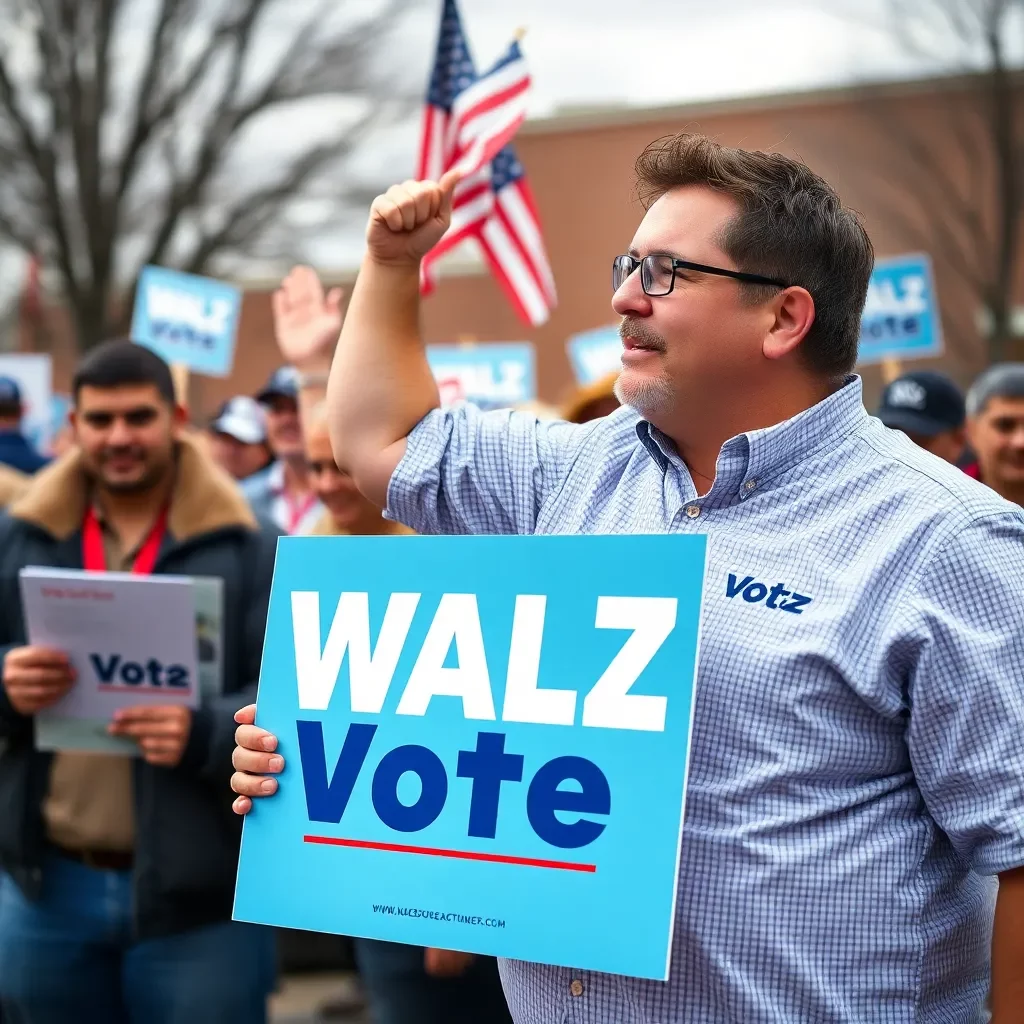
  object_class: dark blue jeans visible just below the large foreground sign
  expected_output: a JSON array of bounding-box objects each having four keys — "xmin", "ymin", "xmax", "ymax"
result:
[{"xmin": 353, "ymin": 939, "xmax": 512, "ymax": 1024}]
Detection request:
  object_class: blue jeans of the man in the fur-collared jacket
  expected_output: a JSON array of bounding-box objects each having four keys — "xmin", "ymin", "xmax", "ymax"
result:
[{"xmin": 0, "ymin": 857, "xmax": 274, "ymax": 1024}]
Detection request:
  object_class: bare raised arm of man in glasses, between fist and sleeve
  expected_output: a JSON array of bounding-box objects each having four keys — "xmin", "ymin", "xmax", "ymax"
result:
[{"xmin": 328, "ymin": 258, "xmax": 440, "ymax": 480}]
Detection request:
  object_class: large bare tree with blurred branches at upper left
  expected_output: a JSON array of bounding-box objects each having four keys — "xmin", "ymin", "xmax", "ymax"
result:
[{"xmin": 0, "ymin": 0, "xmax": 417, "ymax": 346}]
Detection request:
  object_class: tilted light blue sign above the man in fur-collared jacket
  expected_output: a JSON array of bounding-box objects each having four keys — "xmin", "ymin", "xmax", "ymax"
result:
[{"xmin": 131, "ymin": 266, "xmax": 242, "ymax": 377}]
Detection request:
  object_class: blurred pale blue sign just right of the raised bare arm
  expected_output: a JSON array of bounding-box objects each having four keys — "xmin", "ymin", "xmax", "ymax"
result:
[{"xmin": 427, "ymin": 342, "xmax": 537, "ymax": 409}]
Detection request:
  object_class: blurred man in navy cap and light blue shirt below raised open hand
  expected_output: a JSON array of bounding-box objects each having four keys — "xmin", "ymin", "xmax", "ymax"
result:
[{"xmin": 242, "ymin": 367, "xmax": 324, "ymax": 534}]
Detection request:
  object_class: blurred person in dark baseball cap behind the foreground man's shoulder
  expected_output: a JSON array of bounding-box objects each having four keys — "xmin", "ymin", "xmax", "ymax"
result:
[{"xmin": 878, "ymin": 370, "xmax": 967, "ymax": 465}]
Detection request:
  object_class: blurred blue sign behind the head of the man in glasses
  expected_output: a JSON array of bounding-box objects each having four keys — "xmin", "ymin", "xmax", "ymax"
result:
[{"xmin": 857, "ymin": 253, "xmax": 942, "ymax": 365}]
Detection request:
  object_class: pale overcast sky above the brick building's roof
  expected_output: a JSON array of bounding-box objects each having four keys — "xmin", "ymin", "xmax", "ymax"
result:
[{"xmin": 5, "ymin": 0, "xmax": 1007, "ymax": 315}]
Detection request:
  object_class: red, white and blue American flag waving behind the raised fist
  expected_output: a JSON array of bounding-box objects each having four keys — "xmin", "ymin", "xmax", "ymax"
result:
[{"xmin": 417, "ymin": 0, "xmax": 556, "ymax": 326}]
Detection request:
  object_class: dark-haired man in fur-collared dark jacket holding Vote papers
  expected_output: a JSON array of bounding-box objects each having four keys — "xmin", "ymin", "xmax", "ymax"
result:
[{"xmin": 0, "ymin": 341, "xmax": 276, "ymax": 1024}]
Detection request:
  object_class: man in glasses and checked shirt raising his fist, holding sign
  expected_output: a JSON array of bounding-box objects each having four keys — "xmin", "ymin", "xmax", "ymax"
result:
[{"xmin": 232, "ymin": 135, "xmax": 1024, "ymax": 1024}]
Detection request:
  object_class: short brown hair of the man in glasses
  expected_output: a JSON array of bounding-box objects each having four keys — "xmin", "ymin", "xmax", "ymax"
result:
[{"xmin": 636, "ymin": 133, "xmax": 874, "ymax": 378}]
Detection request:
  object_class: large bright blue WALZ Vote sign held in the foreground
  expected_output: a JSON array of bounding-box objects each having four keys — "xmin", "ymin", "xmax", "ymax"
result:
[{"xmin": 234, "ymin": 536, "xmax": 707, "ymax": 979}]
